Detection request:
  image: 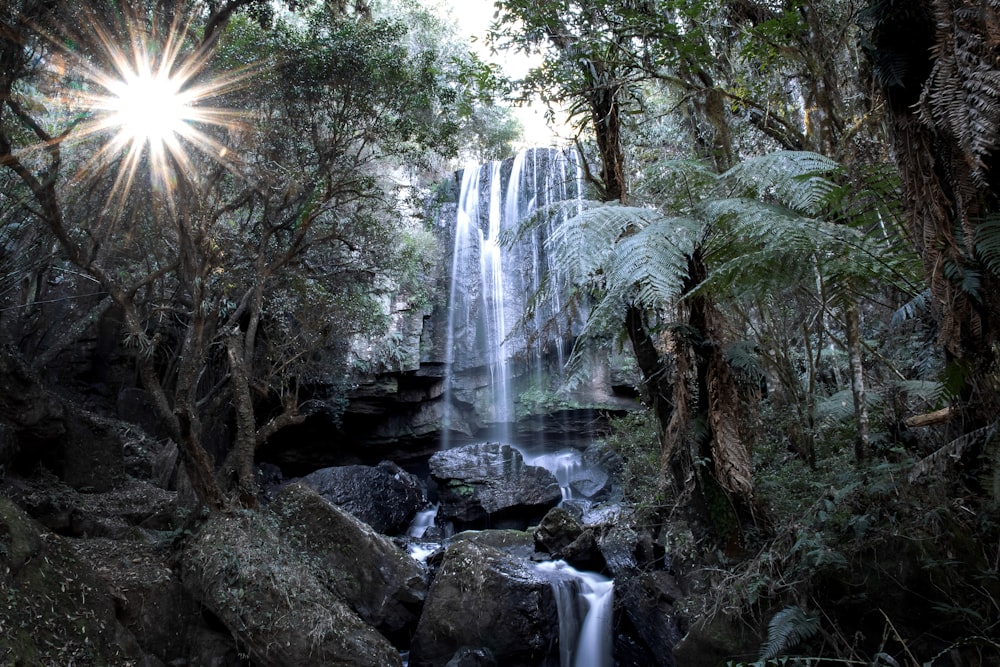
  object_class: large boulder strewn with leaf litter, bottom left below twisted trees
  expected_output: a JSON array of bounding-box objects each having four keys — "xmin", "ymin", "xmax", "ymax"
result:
[{"xmin": 181, "ymin": 511, "xmax": 402, "ymax": 667}]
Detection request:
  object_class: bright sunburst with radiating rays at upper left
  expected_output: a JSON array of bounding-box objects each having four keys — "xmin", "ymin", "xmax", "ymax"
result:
[{"xmin": 47, "ymin": 3, "xmax": 250, "ymax": 213}]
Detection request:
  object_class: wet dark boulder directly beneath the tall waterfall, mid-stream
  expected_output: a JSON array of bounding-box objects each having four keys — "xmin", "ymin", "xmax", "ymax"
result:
[{"xmin": 429, "ymin": 442, "xmax": 562, "ymax": 530}]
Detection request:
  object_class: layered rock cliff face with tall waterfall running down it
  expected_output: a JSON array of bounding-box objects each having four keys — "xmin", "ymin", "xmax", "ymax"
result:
[{"xmin": 268, "ymin": 150, "xmax": 634, "ymax": 466}]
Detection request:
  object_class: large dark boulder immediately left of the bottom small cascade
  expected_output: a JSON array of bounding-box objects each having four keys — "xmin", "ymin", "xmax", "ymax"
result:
[{"xmin": 410, "ymin": 540, "xmax": 559, "ymax": 667}]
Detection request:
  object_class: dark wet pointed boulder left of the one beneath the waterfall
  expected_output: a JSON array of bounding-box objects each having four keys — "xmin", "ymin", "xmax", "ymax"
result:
[{"xmin": 299, "ymin": 461, "xmax": 427, "ymax": 535}]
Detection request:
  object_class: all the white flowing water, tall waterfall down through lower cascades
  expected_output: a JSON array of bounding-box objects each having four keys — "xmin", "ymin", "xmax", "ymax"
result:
[{"xmin": 432, "ymin": 149, "xmax": 614, "ymax": 667}]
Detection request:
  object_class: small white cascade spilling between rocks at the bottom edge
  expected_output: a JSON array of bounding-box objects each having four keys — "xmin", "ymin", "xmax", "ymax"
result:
[{"xmin": 535, "ymin": 561, "xmax": 615, "ymax": 667}]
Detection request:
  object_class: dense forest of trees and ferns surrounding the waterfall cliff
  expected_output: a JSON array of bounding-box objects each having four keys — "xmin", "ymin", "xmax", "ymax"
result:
[{"xmin": 0, "ymin": 0, "xmax": 1000, "ymax": 666}]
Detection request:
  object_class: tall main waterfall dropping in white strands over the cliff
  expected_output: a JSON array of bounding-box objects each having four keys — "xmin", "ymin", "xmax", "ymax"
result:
[{"xmin": 442, "ymin": 149, "xmax": 583, "ymax": 448}]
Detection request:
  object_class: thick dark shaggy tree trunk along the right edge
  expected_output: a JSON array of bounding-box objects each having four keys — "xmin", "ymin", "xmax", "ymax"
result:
[{"xmin": 862, "ymin": 0, "xmax": 1000, "ymax": 442}]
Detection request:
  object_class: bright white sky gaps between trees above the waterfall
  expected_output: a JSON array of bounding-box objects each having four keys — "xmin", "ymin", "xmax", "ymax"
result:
[{"xmin": 436, "ymin": 0, "xmax": 565, "ymax": 146}]
